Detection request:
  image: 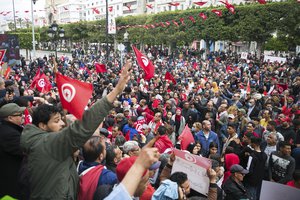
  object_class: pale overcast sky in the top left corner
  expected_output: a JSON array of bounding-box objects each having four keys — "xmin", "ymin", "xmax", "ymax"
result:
[{"xmin": 0, "ymin": 0, "xmax": 45, "ymax": 20}]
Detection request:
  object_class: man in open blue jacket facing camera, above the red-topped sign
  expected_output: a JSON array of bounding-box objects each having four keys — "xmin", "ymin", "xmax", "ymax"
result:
[{"xmin": 195, "ymin": 120, "xmax": 220, "ymax": 157}]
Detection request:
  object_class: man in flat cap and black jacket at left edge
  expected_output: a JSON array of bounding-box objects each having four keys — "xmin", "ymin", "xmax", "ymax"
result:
[{"xmin": 0, "ymin": 103, "xmax": 25, "ymax": 198}]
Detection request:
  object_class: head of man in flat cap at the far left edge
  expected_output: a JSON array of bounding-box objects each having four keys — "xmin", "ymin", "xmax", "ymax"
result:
[{"xmin": 0, "ymin": 103, "xmax": 26, "ymax": 126}]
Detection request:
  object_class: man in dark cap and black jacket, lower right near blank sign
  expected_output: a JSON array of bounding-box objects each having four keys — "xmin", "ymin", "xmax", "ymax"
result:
[{"xmin": 223, "ymin": 164, "xmax": 249, "ymax": 200}]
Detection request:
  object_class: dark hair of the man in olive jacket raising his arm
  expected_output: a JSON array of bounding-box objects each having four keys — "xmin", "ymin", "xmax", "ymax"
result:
[{"xmin": 32, "ymin": 104, "xmax": 60, "ymax": 126}]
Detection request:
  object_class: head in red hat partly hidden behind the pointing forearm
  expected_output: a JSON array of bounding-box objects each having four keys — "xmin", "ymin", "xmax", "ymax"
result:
[{"xmin": 116, "ymin": 156, "xmax": 149, "ymax": 197}]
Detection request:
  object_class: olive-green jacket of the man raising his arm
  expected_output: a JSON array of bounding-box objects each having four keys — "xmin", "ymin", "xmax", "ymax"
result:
[{"xmin": 21, "ymin": 97, "xmax": 113, "ymax": 199}]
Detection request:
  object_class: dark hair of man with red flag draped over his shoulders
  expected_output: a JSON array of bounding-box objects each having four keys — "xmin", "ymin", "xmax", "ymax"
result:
[{"xmin": 82, "ymin": 136, "xmax": 104, "ymax": 162}]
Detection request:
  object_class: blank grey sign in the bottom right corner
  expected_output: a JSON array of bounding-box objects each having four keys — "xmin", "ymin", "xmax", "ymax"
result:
[{"xmin": 260, "ymin": 181, "xmax": 300, "ymax": 200}]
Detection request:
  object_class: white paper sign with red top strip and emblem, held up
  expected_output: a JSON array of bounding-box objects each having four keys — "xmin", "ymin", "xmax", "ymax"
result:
[{"xmin": 172, "ymin": 149, "xmax": 211, "ymax": 196}]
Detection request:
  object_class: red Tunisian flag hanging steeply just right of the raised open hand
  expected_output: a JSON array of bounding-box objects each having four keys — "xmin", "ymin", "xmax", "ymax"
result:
[{"xmin": 132, "ymin": 45, "xmax": 155, "ymax": 80}]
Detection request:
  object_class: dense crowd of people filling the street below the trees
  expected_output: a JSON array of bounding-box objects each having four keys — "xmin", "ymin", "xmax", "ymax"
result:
[{"xmin": 0, "ymin": 47, "xmax": 300, "ymax": 200}]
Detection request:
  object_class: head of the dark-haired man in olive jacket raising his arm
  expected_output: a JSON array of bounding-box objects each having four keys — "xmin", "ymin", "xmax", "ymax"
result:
[{"xmin": 32, "ymin": 104, "xmax": 65, "ymax": 132}]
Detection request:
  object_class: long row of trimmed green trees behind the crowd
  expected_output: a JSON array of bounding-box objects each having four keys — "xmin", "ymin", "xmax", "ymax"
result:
[{"xmin": 12, "ymin": 0, "xmax": 300, "ymax": 51}]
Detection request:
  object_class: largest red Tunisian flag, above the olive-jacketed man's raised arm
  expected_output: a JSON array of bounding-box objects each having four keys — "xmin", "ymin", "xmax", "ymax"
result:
[{"xmin": 56, "ymin": 73, "xmax": 93, "ymax": 119}]
